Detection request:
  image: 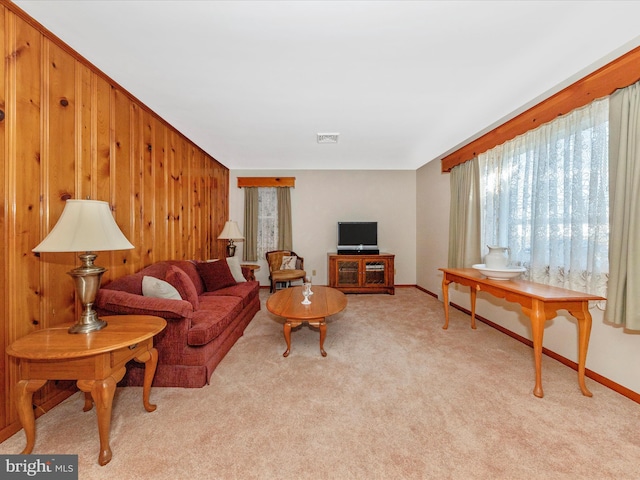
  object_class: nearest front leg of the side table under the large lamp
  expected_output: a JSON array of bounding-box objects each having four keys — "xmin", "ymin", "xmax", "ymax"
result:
[{"xmin": 77, "ymin": 367, "xmax": 126, "ymax": 465}]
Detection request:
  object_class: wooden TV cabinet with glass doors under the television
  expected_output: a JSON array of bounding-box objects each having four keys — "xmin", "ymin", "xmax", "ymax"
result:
[{"xmin": 329, "ymin": 253, "xmax": 395, "ymax": 295}]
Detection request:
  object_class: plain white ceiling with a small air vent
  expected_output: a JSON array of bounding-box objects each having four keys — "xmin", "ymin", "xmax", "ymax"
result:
[{"xmin": 15, "ymin": 0, "xmax": 640, "ymax": 170}]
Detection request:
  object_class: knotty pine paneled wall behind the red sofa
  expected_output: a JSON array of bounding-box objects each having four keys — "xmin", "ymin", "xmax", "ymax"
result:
[{"xmin": 0, "ymin": 2, "xmax": 229, "ymax": 442}]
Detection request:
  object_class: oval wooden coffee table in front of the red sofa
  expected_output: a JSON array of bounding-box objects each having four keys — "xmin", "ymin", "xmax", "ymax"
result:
[{"xmin": 267, "ymin": 286, "xmax": 347, "ymax": 357}]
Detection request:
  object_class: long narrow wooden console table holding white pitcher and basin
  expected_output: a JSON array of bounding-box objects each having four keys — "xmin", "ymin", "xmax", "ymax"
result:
[{"xmin": 440, "ymin": 268, "xmax": 605, "ymax": 398}]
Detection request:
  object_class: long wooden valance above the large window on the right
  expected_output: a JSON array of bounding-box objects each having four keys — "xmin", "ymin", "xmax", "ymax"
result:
[{"xmin": 440, "ymin": 47, "xmax": 640, "ymax": 172}]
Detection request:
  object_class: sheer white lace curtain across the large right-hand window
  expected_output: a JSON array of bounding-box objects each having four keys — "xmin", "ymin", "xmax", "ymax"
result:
[{"xmin": 478, "ymin": 98, "xmax": 609, "ymax": 295}]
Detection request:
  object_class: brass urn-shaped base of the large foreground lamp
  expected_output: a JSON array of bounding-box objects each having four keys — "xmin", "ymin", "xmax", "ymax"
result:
[{"xmin": 68, "ymin": 252, "xmax": 107, "ymax": 333}]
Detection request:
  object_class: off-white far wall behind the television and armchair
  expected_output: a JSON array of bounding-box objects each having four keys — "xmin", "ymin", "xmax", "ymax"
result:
[{"xmin": 229, "ymin": 170, "xmax": 416, "ymax": 285}]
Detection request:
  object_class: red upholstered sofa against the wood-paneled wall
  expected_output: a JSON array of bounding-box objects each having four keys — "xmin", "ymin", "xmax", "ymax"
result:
[{"xmin": 96, "ymin": 260, "xmax": 260, "ymax": 388}]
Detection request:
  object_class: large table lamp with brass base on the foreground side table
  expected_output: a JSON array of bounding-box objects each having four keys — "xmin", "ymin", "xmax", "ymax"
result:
[{"xmin": 33, "ymin": 200, "xmax": 134, "ymax": 333}]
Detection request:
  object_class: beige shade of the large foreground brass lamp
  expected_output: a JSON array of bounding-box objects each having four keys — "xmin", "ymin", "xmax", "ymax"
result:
[{"xmin": 33, "ymin": 200, "xmax": 134, "ymax": 252}]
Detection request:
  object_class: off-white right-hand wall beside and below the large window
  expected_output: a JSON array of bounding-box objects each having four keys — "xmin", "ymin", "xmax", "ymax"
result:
[{"xmin": 416, "ymin": 162, "xmax": 640, "ymax": 393}]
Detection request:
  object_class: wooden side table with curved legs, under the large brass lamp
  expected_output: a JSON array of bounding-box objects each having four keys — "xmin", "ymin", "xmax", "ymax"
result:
[{"xmin": 7, "ymin": 315, "xmax": 167, "ymax": 465}]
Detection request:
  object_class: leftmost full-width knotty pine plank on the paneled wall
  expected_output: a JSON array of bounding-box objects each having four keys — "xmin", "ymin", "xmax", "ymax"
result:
[{"xmin": 10, "ymin": 12, "xmax": 44, "ymax": 342}]
